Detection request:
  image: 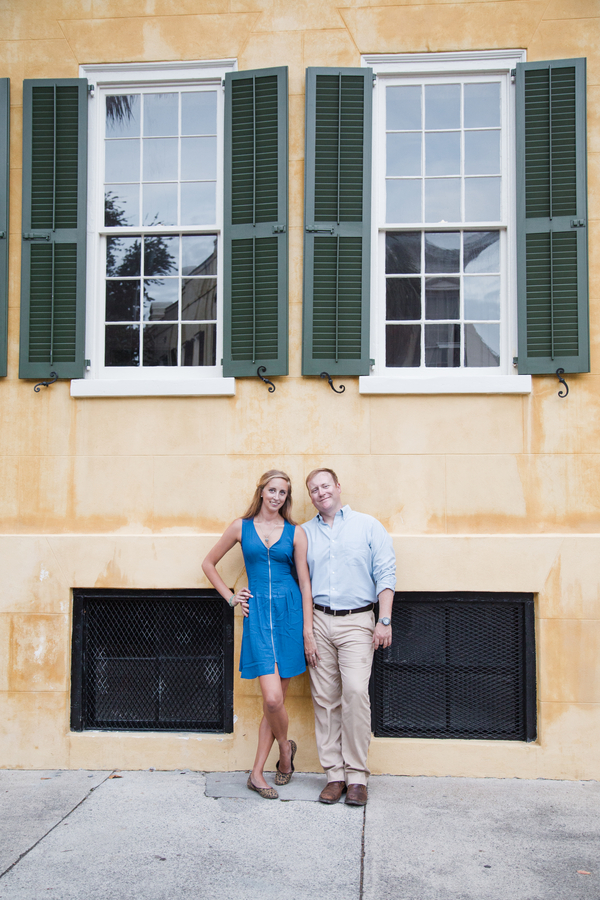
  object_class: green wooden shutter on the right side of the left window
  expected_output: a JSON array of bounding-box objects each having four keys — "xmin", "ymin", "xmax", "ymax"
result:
[{"xmin": 223, "ymin": 67, "xmax": 288, "ymax": 377}]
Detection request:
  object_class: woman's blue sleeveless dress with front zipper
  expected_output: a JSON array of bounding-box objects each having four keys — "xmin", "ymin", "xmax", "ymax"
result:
[{"xmin": 240, "ymin": 519, "xmax": 306, "ymax": 678}]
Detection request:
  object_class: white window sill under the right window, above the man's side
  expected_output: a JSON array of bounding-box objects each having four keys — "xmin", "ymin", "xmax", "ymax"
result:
[{"xmin": 358, "ymin": 375, "xmax": 531, "ymax": 394}]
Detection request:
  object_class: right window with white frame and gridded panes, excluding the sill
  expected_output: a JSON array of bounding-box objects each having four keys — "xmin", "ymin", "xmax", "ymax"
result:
[{"xmin": 373, "ymin": 64, "xmax": 514, "ymax": 377}]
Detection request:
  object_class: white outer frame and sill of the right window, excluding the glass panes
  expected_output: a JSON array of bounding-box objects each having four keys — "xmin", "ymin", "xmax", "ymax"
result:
[{"xmin": 359, "ymin": 50, "xmax": 531, "ymax": 394}]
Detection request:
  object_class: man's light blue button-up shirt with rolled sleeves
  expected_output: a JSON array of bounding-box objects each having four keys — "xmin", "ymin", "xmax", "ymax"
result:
[{"xmin": 302, "ymin": 506, "xmax": 396, "ymax": 609}]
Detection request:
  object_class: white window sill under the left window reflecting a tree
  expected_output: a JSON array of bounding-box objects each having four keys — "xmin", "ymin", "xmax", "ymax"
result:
[{"xmin": 71, "ymin": 378, "xmax": 235, "ymax": 397}]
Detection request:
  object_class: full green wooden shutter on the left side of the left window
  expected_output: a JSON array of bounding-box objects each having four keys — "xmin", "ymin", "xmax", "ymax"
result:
[{"xmin": 19, "ymin": 78, "xmax": 88, "ymax": 378}]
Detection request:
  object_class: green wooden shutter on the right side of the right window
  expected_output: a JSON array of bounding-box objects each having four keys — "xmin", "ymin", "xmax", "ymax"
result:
[{"xmin": 516, "ymin": 59, "xmax": 589, "ymax": 375}]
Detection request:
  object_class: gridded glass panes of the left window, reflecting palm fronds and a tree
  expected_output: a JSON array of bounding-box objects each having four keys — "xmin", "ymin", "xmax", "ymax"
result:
[{"xmin": 103, "ymin": 86, "xmax": 219, "ymax": 371}]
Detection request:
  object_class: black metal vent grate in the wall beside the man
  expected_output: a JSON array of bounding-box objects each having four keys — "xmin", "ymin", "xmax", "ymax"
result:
[{"xmin": 372, "ymin": 593, "xmax": 536, "ymax": 741}]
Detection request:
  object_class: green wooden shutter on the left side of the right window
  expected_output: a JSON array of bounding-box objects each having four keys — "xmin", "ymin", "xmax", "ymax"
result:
[{"xmin": 302, "ymin": 68, "xmax": 373, "ymax": 376}]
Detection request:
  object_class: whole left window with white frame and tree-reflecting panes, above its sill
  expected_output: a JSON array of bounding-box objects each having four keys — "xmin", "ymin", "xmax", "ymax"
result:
[{"xmin": 83, "ymin": 71, "xmax": 225, "ymax": 384}]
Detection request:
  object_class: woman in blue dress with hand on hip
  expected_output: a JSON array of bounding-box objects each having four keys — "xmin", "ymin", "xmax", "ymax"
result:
[{"xmin": 202, "ymin": 469, "xmax": 317, "ymax": 800}]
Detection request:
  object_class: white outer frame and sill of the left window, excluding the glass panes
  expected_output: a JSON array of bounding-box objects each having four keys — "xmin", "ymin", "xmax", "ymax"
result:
[{"xmin": 71, "ymin": 59, "xmax": 237, "ymax": 397}]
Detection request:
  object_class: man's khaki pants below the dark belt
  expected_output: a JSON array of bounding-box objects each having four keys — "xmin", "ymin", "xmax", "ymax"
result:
[{"xmin": 309, "ymin": 609, "xmax": 375, "ymax": 784}]
